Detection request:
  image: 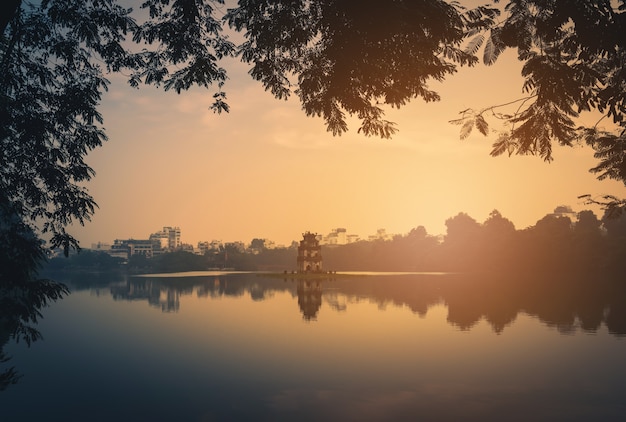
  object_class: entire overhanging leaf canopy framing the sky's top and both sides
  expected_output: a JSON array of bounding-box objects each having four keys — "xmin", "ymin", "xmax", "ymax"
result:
[{"xmin": 0, "ymin": 0, "xmax": 626, "ymax": 310}]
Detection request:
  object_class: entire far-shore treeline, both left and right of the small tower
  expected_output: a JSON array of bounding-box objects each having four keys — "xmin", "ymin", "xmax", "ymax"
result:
[{"xmin": 48, "ymin": 207, "xmax": 626, "ymax": 273}]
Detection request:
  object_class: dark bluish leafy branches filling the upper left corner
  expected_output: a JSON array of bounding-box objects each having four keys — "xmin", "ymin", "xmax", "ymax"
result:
[{"xmin": 0, "ymin": 0, "xmax": 234, "ymax": 258}]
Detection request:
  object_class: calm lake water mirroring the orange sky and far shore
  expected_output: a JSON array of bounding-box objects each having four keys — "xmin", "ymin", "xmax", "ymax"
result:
[{"xmin": 0, "ymin": 273, "xmax": 626, "ymax": 422}]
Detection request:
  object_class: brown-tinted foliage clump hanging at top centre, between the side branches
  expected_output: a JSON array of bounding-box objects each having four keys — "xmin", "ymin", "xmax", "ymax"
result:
[{"xmin": 226, "ymin": 0, "xmax": 496, "ymax": 138}]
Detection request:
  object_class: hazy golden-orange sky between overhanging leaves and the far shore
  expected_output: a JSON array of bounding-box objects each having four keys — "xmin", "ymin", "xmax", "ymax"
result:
[{"xmin": 71, "ymin": 42, "xmax": 626, "ymax": 247}]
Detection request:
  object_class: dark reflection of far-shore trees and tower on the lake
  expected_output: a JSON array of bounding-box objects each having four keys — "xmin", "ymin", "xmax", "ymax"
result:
[{"xmin": 98, "ymin": 274, "xmax": 626, "ymax": 335}]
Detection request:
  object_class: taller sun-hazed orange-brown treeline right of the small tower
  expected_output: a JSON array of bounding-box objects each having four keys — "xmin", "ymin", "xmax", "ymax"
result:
[{"xmin": 322, "ymin": 207, "xmax": 626, "ymax": 272}]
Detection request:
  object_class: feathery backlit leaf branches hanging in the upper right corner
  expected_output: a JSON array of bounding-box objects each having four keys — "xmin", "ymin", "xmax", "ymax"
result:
[{"xmin": 452, "ymin": 0, "xmax": 626, "ymax": 198}]
